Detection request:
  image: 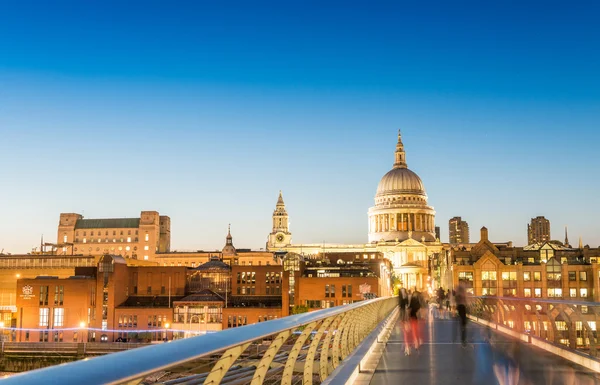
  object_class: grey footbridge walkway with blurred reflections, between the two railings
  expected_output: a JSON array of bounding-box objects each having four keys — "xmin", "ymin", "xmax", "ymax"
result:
[{"xmin": 371, "ymin": 319, "xmax": 600, "ymax": 385}]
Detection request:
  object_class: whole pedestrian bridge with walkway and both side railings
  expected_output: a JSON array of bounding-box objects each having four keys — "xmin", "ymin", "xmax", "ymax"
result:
[{"xmin": 2, "ymin": 297, "xmax": 600, "ymax": 385}]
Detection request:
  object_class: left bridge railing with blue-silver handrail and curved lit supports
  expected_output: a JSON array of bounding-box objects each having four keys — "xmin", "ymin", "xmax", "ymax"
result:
[{"xmin": 2, "ymin": 297, "xmax": 397, "ymax": 385}]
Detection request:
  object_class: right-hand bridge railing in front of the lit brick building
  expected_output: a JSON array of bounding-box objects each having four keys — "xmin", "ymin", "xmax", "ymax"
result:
[{"xmin": 468, "ymin": 296, "xmax": 600, "ymax": 358}]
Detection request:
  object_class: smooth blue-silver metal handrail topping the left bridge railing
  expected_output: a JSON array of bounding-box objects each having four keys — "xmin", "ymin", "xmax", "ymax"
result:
[{"xmin": 2, "ymin": 298, "xmax": 395, "ymax": 385}]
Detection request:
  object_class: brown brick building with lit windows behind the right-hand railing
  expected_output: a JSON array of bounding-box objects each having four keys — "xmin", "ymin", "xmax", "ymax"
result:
[{"xmin": 451, "ymin": 227, "xmax": 600, "ymax": 302}]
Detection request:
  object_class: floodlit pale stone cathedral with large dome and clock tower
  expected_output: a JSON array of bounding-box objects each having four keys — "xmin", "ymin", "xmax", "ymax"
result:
[{"xmin": 267, "ymin": 132, "xmax": 443, "ymax": 290}]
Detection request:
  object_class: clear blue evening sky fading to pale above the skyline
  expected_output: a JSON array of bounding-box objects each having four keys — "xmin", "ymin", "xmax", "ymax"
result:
[{"xmin": 0, "ymin": 0, "xmax": 600, "ymax": 253}]
